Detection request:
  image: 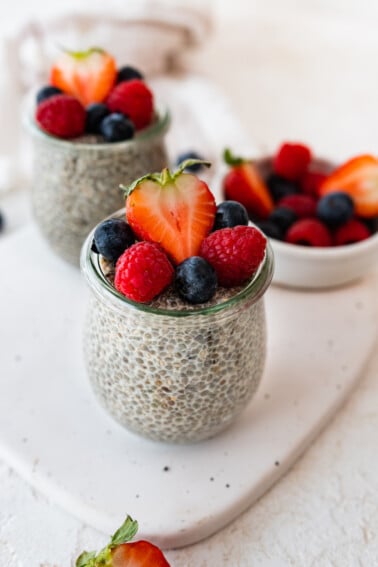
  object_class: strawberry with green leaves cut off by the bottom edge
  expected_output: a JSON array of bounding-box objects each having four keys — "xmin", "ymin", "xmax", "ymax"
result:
[{"xmin": 75, "ymin": 516, "xmax": 170, "ymax": 567}]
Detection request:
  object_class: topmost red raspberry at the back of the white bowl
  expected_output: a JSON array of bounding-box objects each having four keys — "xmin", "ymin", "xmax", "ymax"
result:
[{"xmin": 273, "ymin": 143, "xmax": 311, "ymax": 181}]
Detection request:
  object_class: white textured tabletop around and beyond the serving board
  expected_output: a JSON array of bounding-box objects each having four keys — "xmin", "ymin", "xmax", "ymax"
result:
[{"xmin": 0, "ymin": 0, "xmax": 378, "ymax": 567}]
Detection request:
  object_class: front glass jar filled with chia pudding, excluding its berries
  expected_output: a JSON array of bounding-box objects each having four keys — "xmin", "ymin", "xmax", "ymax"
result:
[{"xmin": 81, "ymin": 222, "xmax": 273, "ymax": 443}]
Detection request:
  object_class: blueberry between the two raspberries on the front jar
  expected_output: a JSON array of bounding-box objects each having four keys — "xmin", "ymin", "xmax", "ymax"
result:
[{"xmin": 175, "ymin": 256, "xmax": 217, "ymax": 303}]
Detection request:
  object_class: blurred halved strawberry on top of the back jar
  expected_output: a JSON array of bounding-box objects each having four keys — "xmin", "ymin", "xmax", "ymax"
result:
[{"xmin": 50, "ymin": 47, "xmax": 117, "ymax": 106}]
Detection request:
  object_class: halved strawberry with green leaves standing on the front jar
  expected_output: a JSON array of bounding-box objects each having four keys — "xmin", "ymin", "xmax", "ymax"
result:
[{"xmin": 123, "ymin": 160, "xmax": 216, "ymax": 264}]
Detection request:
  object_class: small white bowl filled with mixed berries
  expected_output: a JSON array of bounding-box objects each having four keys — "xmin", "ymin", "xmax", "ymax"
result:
[{"xmin": 223, "ymin": 142, "xmax": 378, "ymax": 288}]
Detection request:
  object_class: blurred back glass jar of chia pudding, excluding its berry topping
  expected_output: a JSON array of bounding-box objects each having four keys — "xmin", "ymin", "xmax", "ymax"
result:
[{"xmin": 26, "ymin": 112, "xmax": 170, "ymax": 265}]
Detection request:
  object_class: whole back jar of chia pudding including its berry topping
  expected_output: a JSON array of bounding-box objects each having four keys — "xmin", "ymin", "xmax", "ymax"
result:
[{"xmin": 25, "ymin": 48, "xmax": 170, "ymax": 264}]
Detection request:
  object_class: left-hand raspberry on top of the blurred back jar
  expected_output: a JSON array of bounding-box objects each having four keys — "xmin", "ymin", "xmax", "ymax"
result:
[{"xmin": 36, "ymin": 94, "xmax": 85, "ymax": 138}]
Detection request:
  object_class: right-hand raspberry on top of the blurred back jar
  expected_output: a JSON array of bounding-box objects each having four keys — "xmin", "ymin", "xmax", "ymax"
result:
[{"xmin": 106, "ymin": 79, "xmax": 154, "ymax": 130}]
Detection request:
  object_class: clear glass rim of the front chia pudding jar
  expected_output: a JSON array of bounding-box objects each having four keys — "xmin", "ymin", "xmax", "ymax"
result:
[{"xmin": 80, "ymin": 213, "xmax": 274, "ymax": 319}]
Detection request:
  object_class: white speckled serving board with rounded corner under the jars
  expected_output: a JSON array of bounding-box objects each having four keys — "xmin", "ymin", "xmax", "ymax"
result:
[{"xmin": 0, "ymin": 225, "xmax": 378, "ymax": 548}]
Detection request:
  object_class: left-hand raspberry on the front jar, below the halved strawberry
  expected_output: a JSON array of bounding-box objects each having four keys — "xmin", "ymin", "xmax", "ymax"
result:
[{"xmin": 114, "ymin": 242, "xmax": 174, "ymax": 303}]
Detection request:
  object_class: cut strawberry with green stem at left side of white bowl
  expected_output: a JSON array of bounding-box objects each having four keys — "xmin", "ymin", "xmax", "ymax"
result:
[{"xmin": 223, "ymin": 149, "xmax": 274, "ymax": 219}]
